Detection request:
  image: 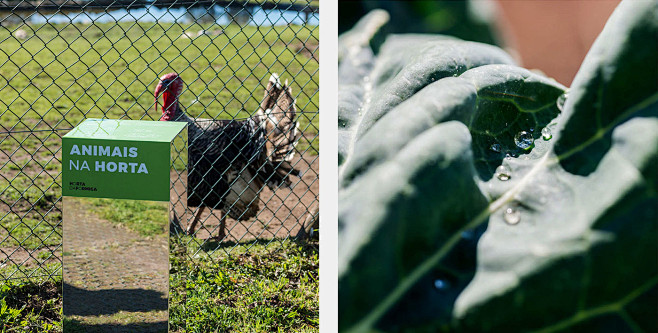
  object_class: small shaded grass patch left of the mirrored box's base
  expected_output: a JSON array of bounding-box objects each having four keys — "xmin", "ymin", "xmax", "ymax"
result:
[{"xmin": 0, "ymin": 277, "xmax": 62, "ymax": 333}]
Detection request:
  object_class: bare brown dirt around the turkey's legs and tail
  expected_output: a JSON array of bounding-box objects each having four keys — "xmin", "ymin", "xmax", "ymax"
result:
[{"xmin": 172, "ymin": 150, "xmax": 319, "ymax": 242}]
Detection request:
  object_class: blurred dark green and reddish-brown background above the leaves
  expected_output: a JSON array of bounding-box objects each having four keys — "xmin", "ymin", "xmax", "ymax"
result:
[{"xmin": 338, "ymin": 0, "xmax": 616, "ymax": 86}]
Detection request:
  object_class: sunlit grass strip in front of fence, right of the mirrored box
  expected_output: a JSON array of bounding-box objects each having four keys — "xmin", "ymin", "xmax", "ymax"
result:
[{"xmin": 169, "ymin": 241, "xmax": 319, "ymax": 332}]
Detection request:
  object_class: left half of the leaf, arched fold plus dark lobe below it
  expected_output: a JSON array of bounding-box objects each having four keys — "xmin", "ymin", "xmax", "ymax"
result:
[{"xmin": 339, "ymin": 61, "xmax": 564, "ymax": 330}]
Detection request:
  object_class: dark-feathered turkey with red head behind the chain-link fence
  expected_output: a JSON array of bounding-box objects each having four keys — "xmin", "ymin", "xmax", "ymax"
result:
[{"xmin": 155, "ymin": 73, "xmax": 301, "ymax": 240}]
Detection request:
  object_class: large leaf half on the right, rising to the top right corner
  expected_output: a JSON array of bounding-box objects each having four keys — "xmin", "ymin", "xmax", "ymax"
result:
[{"xmin": 455, "ymin": 1, "xmax": 658, "ymax": 331}]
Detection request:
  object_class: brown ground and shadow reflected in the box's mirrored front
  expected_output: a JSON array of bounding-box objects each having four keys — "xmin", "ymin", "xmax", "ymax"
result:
[{"xmin": 63, "ymin": 198, "xmax": 169, "ymax": 332}]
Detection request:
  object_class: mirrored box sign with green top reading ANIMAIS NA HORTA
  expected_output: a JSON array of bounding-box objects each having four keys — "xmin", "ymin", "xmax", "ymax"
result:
[{"xmin": 62, "ymin": 119, "xmax": 187, "ymax": 332}]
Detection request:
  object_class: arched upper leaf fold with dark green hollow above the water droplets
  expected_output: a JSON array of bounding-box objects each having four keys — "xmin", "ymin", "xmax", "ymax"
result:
[{"xmin": 341, "ymin": 65, "xmax": 564, "ymax": 187}]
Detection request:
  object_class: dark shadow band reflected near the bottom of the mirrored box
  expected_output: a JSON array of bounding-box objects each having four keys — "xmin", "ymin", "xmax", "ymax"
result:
[{"xmin": 63, "ymin": 283, "xmax": 168, "ymax": 316}]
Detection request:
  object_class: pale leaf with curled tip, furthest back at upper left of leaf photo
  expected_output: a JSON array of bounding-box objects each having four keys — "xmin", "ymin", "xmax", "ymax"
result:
[{"xmin": 338, "ymin": 11, "xmax": 514, "ymax": 164}]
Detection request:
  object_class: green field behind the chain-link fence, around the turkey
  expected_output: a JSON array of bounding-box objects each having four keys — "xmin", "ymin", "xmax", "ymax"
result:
[{"xmin": 0, "ymin": 18, "xmax": 319, "ymax": 279}]
